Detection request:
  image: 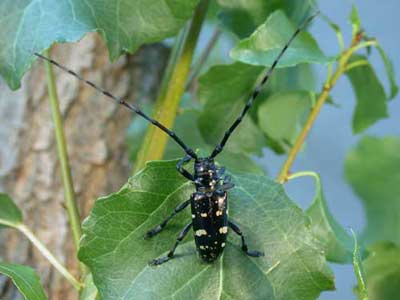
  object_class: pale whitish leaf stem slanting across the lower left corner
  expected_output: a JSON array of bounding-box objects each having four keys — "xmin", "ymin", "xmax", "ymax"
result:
[{"xmin": 17, "ymin": 224, "xmax": 83, "ymax": 291}]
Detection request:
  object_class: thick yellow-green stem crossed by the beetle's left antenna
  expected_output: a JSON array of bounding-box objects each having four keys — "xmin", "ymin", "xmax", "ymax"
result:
[{"xmin": 134, "ymin": 0, "xmax": 210, "ymax": 173}]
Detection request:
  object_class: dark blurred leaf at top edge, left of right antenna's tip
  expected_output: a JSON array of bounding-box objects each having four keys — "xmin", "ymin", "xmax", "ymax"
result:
[{"xmin": 217, "ymin": 0, "xmax": 310, "ymax": 38}]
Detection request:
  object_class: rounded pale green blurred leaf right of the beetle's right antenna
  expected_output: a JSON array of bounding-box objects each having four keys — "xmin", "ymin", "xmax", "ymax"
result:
[{"xmin": 258, "ymin": 91, "xmax": 315, "ymax": 150}]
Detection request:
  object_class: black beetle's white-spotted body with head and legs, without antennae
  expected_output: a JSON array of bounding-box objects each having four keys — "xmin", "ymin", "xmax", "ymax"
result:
[{"xmin": 146, "ymin": 156, "xmax": 263, "ymax": 265}]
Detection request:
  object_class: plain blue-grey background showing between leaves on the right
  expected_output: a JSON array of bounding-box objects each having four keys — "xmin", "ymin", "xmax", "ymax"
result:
[{"xmin": 260, "ymin": 0, "xmax": 400, "ymax": 300}]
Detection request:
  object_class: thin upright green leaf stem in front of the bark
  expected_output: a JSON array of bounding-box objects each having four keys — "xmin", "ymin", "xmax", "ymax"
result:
[{"xmin": 45, "ymin": 50, "xmax": 84, "ymax": 271}]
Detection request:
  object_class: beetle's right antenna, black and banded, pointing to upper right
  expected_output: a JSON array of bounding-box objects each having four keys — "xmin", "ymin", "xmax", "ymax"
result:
[{"xmin": 210, "ymin": 11, "xmax": 319, "ymax": 158}]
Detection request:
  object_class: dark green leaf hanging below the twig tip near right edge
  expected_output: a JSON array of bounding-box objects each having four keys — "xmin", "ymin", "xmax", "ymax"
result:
[{"xmin": 346, "ymin": 55, "xmax": 388, "ymax": 134}]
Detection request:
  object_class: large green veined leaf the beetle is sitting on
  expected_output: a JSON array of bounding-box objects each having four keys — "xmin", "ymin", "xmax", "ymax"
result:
[{"xmin": 79, "ymin": 161, "xmax": 333, "ymax": 300}]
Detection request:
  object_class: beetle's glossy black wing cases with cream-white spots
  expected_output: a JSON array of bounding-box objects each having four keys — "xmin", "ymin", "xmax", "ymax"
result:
[{"xmin": 191, "ymin": 191, "xmax": 228, "ymax": 262}]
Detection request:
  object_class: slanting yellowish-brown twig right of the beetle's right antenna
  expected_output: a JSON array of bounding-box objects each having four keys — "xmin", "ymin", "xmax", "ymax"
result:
[{"xmin": 276, "ymin": 33, "xmax": 373, "ymax": 183}]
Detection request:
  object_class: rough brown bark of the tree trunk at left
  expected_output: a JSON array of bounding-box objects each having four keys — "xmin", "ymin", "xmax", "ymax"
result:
[{"xmin": 0, "ymin": 34, "xmax": 168, "ymax": 300}]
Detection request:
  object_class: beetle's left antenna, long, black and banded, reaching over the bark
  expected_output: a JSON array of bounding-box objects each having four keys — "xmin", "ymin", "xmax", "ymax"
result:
[{"xmin": 35, "ymin": 53, "xmax": 197, "ymax": 159}]
